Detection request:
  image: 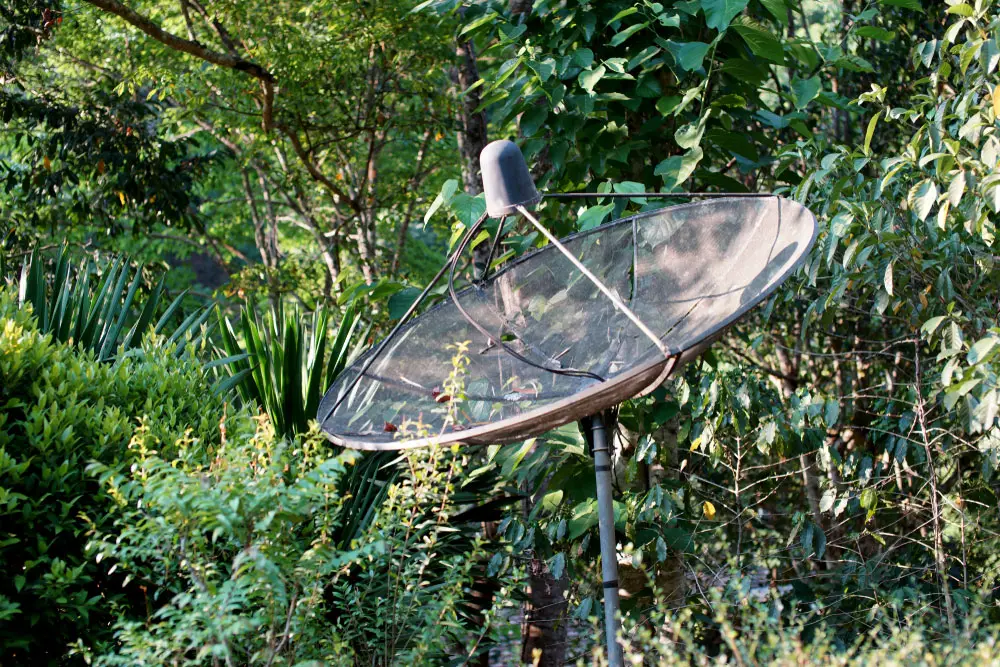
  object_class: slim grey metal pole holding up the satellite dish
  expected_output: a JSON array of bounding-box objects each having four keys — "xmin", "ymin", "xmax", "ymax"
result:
[{"xmin": 590, "ymin": 415, "xmax": 623, "ymax": 667}]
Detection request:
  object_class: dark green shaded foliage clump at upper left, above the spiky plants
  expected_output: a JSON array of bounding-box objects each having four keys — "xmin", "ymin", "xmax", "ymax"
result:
[{"xmin": 0, "ymin": 87, "xmax": 218, "ymax": 246}]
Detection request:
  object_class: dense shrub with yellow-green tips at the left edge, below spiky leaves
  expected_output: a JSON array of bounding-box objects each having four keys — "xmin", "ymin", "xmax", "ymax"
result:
[{"xmin": 0, "ymin": 289, "xmax": 222, "ymax": 664}]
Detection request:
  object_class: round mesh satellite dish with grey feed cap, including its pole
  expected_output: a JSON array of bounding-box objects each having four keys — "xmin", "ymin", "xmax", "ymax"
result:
[{"xmin": 318, "ymin": 142, "xmax": 817, "ymax": 667}]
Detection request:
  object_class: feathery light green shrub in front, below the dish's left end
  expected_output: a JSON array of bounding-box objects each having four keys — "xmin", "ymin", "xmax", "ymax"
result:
[{"xmin": 87, "ymin": 416, "xmax": 492, "ymax": 665}]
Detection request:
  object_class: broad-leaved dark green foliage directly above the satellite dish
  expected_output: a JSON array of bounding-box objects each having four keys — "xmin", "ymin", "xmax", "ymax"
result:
[{"xmin": 446, "ymin": 0, "xmax": 828, "ymax": 207}]
